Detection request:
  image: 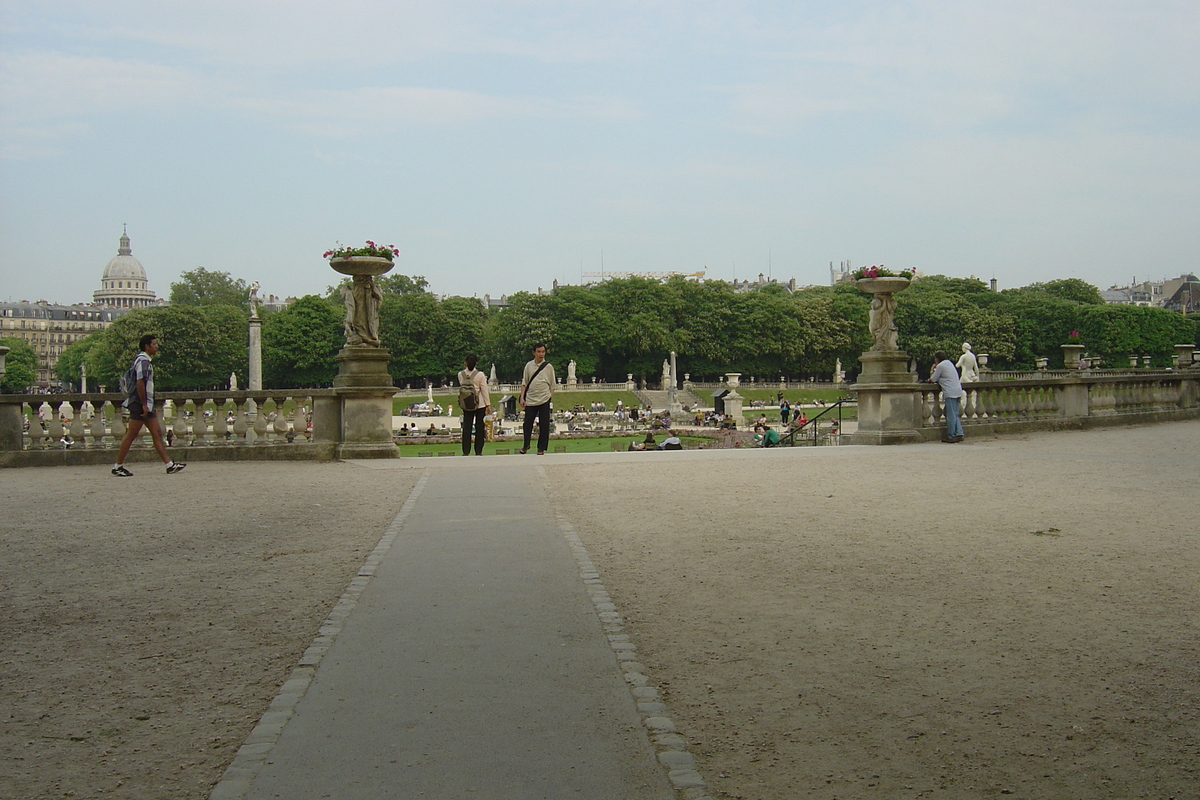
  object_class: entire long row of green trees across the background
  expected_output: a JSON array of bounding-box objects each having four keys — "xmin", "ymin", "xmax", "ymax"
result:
[{"xmin": 49, "ymin": 269, "xmax": 1198, "ymax": 390}]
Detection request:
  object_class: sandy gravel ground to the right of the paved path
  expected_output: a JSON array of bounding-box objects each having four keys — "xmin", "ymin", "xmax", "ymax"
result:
[{"xmin": 548, "ymin": 422, "xmax": 1200, "ymax": 800}]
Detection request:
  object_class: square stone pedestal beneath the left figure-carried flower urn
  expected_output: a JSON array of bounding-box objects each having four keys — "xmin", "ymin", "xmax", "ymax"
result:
[{"xmin": 333, "ymin": 347, "xmax": 400, "ymax": 459}]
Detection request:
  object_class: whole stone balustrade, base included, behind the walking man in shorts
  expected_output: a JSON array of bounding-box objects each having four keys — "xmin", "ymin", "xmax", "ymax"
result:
[{"xmin": 0, "ymin": 389, "xmax": 340, "ymax": 465}]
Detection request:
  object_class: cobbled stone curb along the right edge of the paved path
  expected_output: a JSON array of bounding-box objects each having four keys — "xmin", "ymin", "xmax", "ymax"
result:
[{"xmin": 538, "ymin": 467, "xmax": 713, "ymax": 800}]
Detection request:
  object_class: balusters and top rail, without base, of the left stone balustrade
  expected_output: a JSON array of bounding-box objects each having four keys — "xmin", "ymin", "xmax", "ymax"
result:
[{"xmin": 0, "ymin": 389, "xmax": 332, "ymax": 450}]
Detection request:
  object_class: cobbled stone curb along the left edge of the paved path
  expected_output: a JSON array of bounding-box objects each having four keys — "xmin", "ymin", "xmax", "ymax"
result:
[{"xmin": 209, "ymin": 469, "xmax": 430, "ymax": 800}]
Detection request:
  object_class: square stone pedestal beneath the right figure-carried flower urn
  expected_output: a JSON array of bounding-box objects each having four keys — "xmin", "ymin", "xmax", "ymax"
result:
[{"xmin": 842, "ymin": 350, "xmax": 923, "ymax": 445}]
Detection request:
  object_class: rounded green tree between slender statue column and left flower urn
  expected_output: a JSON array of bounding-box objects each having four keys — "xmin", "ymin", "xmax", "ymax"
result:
[{"xmin": 263, "ymin": 295, "xmax": 346, "ymax": 387}]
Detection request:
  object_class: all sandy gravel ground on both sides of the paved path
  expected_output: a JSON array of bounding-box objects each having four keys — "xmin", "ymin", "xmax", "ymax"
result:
[{"xmin": 0, "ymin": 422, "xmax": 1200, "ymax": 800}]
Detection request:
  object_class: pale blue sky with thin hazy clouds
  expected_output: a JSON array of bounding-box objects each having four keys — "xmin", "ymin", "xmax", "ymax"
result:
[{"xmin": 0, "ymin": 0, "xmax": 1200, "ymax": 303}]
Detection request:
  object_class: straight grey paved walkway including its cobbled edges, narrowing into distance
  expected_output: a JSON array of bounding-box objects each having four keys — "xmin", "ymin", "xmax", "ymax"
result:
[{"xmin": 211, "ymin": 458, "xmax": 681, "ymax": 800}]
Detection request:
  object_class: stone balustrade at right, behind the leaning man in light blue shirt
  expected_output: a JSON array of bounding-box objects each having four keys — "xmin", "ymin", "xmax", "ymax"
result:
[{"xmin": 914, "ymin": 369, "xmax": 1200, "ymax": 439}]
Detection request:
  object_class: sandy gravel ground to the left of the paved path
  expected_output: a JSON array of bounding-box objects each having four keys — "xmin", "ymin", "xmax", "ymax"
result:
[{"xmin": 0, "ymin": 463, "xmax": 418, "ymax": 800}]
